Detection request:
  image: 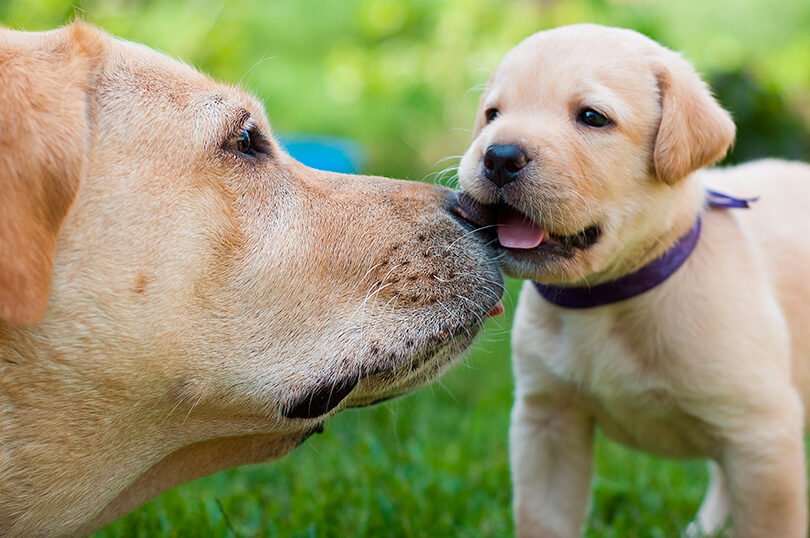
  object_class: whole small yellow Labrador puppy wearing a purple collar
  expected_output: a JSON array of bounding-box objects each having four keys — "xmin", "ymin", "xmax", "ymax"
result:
[{"xmin": 460, "ymin": 25, "xmax": 810, "ymax": 538}]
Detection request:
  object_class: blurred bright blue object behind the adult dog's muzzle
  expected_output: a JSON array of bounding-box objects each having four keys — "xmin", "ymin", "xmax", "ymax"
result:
[{"xmin": 278, "ymin": 134, "xmax": 364, "ymax": 174}]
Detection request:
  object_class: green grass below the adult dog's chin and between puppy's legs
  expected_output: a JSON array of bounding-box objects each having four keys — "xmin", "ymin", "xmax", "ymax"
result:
[{"xmin": 91, "ymin": 276, "xmax": 736, "ymax": 538}]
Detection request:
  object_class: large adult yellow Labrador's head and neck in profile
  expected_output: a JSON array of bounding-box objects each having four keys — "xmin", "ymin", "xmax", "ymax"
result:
[{"xmin": 0, "ymin": 24, "xmax": 502, "ymax": 536}]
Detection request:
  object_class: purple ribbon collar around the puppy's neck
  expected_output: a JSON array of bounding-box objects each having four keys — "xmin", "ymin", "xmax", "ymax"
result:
[{"xmin": 534, "ymin": 190, "xmax": 757, "ymax": 308}]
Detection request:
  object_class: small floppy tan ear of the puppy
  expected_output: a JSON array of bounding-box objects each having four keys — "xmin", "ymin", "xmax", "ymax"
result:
[{"xmin": 653, "ymin": 53, "xmax": 736, "ymax": 185}]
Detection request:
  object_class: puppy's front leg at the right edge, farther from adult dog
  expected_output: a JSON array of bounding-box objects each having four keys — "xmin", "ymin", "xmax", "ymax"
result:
[{"xmin": 723, "ymin": 388, "xmax": 808, "ymax": 538}]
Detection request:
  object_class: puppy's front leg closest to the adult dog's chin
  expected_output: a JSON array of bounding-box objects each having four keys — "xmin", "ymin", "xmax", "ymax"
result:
[{"xmin": 510, "ymin": 395, "xmax": 593, "ymax": 538}]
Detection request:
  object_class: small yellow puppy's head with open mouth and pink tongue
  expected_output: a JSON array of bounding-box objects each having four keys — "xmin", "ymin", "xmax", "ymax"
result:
[{"xmin": 459, "ymin": 25, "xmax": 734, "ymax": 284}]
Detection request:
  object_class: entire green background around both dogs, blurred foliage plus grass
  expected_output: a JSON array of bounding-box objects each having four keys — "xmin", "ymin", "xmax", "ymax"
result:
[{"xmin": 0, "ymin": 0, "xmax": 810, "ymax": 537}]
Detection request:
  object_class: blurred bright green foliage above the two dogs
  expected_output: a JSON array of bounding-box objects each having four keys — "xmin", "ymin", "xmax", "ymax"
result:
[{"xmin": 0, "ymin": 0, "xmax": 810, "ymax": 179}]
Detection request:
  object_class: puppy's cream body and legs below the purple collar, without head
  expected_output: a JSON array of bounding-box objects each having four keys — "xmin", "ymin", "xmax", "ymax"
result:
[{"xmin": 511, "ymin": 162, "xmax": 810, "ymax": 536}]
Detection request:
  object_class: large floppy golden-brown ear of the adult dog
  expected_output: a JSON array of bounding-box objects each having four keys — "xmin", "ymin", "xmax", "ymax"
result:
[{"xmin": 0, "ymin": 23, "xmax": 104, "ymax": 326}]
